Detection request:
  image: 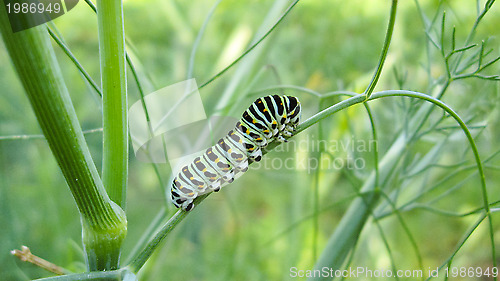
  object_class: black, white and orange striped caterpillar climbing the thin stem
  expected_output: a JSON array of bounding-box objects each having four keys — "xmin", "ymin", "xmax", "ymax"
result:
[{"xmin": 171, "ymin": 95, "xmax": 301, "ymax": 211}]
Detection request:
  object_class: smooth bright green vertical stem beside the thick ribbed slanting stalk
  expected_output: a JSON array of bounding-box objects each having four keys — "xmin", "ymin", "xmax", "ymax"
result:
[{"xmin": 97, "ymin": 0, "xmax": 128, "ymax": 209}]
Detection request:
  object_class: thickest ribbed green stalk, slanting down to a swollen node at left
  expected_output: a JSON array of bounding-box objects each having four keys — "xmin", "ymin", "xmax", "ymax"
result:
[{"xmin": 0, "ymin": 0, "xmax": 127, "ymax": 269}]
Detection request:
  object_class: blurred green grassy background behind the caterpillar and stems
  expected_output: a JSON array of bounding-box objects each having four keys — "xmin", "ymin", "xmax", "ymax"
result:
[{"xmin": 0, "ymin": 0, "xmax": 500, "ymax": 280}]
